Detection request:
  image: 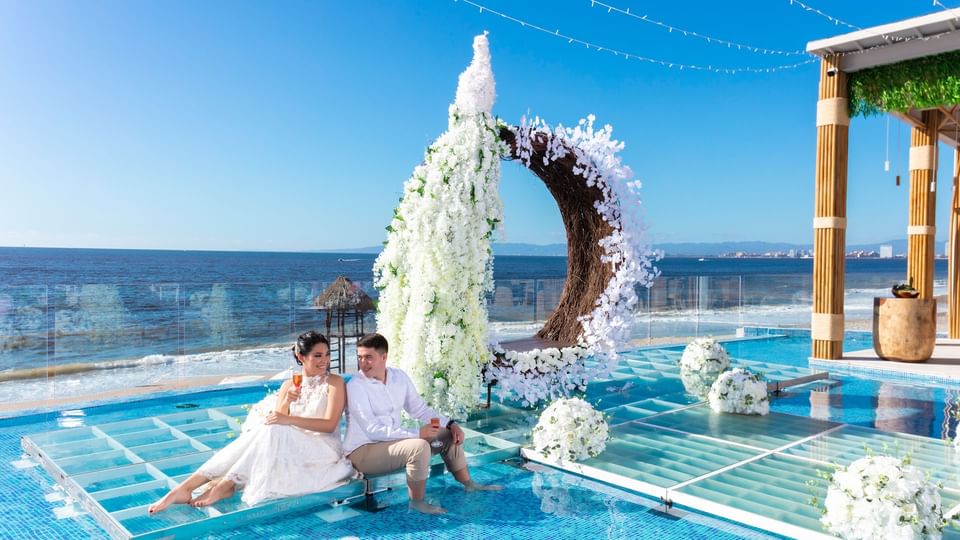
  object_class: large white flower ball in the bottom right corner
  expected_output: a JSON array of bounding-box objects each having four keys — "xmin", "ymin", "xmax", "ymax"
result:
[{"xmin": 820, "ymin": 456, "xmax": 946, "ymax": 540}]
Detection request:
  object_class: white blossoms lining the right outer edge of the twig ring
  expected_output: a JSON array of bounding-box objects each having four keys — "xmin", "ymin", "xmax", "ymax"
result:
[{"xmin": 487, "ymin": 115, "xmax": 659, "ymax": 403}]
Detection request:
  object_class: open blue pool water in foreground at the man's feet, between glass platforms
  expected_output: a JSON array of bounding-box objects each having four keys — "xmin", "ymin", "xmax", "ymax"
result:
[{"xmin": 191, "ymin": 463, "xmax": 775, "ymax": 540}]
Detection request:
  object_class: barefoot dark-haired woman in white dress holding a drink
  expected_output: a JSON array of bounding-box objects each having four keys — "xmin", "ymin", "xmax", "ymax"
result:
[{"xmin": 149, "ymin": 331, "xmax": 357, "ymax": 514}]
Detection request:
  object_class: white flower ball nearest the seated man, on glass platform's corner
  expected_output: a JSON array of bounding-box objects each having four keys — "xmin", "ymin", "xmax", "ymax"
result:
[{"xmin": 533, "ymin": 398, "xmax": 608, "ymax": 463}]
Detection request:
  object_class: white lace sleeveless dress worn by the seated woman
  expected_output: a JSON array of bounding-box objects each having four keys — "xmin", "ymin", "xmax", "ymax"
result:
[{"xmin": 198, "ymin": 376, "xmax": 358, "ymax": 506}]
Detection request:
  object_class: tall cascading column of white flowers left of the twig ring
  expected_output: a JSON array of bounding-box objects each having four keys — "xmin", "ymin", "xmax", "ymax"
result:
[{"xmin": 374, "ymin": 35, "xmax": 507, "ymax": 419}]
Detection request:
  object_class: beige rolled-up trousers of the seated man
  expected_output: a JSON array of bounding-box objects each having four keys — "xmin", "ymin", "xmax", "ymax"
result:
[{"xmin": 347, "ymin": 428, "xmax": 467, "ymax": 482}]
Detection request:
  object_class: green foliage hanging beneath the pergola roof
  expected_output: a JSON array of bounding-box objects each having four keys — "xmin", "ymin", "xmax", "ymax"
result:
[{"xmin": 847, "ymin": 51, "xmax": 960, "ymax": 117}]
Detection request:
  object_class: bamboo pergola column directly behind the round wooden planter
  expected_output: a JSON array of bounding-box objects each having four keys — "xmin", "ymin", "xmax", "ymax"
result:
[{"xmin": 907, "ymin": 110, "xmax": 941, "ymax": 298}]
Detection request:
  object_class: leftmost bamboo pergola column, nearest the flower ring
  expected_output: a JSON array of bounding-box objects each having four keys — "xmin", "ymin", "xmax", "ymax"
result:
[{"xmin": 810, "ymin": 56, "xmax": 850, "ymax": 359}]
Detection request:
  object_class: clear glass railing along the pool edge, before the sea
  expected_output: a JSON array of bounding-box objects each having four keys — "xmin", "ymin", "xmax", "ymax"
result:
[{"xmin": 0, "ymin": 274, "xmax": 945, "ymax": 405}]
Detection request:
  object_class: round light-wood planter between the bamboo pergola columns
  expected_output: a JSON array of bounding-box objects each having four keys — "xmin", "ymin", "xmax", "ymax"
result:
[{"xmin": 873, "ymin": 298, "xmax": 937, "ymax": 362}]
